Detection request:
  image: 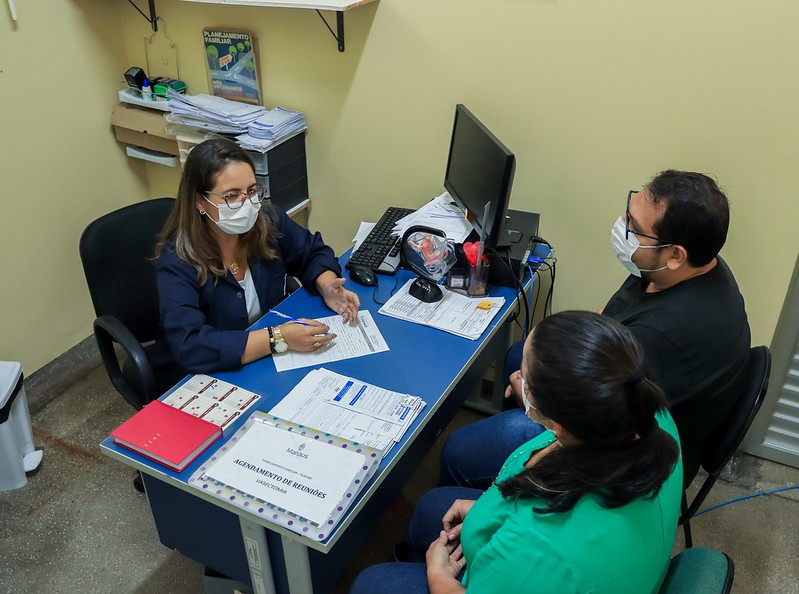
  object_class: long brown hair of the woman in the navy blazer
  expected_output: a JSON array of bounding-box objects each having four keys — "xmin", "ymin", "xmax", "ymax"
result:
[{"xmin": 155, "ymin": 138, "xmax": 278, "ymax": 285}]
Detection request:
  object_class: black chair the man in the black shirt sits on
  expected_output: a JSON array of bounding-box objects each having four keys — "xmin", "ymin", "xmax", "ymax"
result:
[{"xmin": 679, "ymin": 346, "xmax": 771, "ymax": 548}]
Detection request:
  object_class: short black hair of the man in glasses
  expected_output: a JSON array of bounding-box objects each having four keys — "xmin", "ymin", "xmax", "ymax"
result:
[{"xmin": 647, "ymin": 170, "xmax": 730, "ymax": 266}]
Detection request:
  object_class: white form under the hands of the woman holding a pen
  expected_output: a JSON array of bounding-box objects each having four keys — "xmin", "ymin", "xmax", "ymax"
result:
[{"xmin": 272, "ymin": 311, "xmax": 388, "ymax": 371}]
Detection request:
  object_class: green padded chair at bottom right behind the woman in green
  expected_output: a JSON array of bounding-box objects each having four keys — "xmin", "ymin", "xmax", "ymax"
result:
[{"xmin": 658, "ymin": 547, "xmax": 735, "ymax": 594}]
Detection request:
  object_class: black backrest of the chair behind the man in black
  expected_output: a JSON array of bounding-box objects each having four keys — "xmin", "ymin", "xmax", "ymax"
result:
[{"xmin": 700, "ymin": 346, "xmax": 771, "ymax": 475}]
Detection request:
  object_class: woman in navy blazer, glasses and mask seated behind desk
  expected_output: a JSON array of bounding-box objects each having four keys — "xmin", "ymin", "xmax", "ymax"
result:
[{"xmin": 156, "ymin": 139, "xmax": 360, "ymax": 373}]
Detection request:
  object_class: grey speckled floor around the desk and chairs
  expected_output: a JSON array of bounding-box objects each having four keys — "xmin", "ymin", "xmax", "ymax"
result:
[{"xmin": 0, "ymin": 368, "xmax": 799, "ymax": 594}]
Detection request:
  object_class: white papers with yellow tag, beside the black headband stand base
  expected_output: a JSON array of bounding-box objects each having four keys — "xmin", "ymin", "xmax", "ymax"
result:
[{"xmin": 379, "ymin": 280, "xmax": 505, "ymax": 340}]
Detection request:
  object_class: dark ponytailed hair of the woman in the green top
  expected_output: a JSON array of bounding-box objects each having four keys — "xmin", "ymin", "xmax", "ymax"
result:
[{"xmin": 498, "ymin": 311, "xmax": 679, "ymax": 513}]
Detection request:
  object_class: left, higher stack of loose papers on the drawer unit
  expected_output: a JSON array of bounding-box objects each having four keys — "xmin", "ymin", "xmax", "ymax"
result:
[{"xmin": 164, "ymin": 89, "xmax": 266, "ymax": 134}]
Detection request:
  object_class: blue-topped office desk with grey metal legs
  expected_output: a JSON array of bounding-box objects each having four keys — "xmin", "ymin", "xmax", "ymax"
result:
[{"xmin": 101, "ymin": 255, "xmax": 536, "ymax": 594}]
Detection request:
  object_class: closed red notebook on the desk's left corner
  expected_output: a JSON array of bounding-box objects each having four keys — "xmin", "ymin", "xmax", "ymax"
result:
[{"xmin": 111, "ymin": 400, "xmax": 222, "ymax": 472}]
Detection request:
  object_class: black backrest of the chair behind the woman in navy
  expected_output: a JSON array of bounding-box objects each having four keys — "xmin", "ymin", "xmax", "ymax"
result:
[{"xmin": 80, "ymin": 198, "xmax": 175, "ymax": 342}]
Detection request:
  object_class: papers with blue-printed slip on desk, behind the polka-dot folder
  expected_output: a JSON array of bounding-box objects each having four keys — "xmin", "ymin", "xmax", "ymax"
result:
[{"xmin": 269, "ymin": 369, "xmax": 425, "ymax": 455}]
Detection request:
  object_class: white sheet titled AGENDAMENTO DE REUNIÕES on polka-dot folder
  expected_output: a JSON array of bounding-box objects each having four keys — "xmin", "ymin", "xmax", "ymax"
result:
[{"xmin": 207, "ymin": 422, "xmax": 366, "ymax": 526}]
